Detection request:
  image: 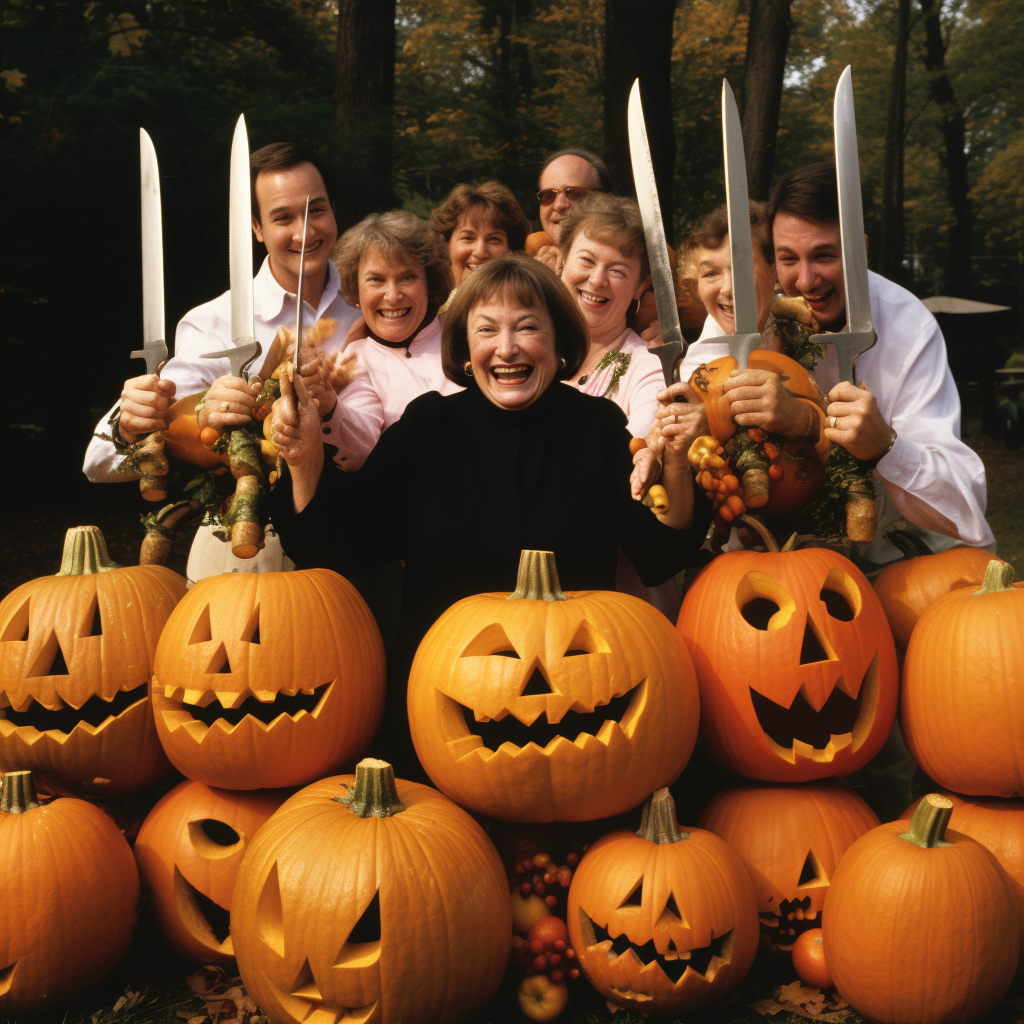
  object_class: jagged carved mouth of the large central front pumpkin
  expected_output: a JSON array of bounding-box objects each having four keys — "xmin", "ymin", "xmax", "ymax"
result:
[{"xmin": 449, "ymin": 679, "xmax": 647, "ymax": 758}]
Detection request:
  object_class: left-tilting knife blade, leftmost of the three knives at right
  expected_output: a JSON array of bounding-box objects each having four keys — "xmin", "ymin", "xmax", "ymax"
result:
[{"xmin": 628, "ymin": 79, "xmax": 686, "ymax": 384}]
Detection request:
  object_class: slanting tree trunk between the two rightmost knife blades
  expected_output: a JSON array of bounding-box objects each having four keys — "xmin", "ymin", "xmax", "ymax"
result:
[{"xmin": 742, "ymin": 0, "xmax": 793, "ymax": 201}]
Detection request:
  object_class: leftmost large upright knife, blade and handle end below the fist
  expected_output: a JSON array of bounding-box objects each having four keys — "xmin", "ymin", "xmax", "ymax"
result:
[{"xmin": 131, "ymin": 128, "xmax": 167, "ymax": 502}]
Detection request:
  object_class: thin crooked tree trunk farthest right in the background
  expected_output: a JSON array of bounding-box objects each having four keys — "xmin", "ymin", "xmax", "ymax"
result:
[{"xmin": 921, "ymin": 0, "xmax": 974, "ymax": 295}]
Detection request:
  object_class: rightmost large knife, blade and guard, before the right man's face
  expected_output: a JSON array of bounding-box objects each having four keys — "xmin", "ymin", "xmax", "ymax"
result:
[{"xmin": 810, "ymin": 66, "xmax": 879, "ymax": 384}]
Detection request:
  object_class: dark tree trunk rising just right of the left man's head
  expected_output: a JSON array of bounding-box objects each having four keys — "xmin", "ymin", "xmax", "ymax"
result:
[{"xmin": 336, "ymin": 0, "xmax": 396, "ymax": 213}]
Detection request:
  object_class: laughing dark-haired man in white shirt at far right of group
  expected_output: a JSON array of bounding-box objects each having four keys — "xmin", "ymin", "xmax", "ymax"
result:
[{"xmin": 770, "ymin": 164, "xmax": 994, "ymax": 562}]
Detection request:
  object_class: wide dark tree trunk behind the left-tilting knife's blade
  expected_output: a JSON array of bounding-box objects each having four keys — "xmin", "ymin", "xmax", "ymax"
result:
[{"xmin": 604, "ymin": 0, "xmax": 678, "ymax": 245}]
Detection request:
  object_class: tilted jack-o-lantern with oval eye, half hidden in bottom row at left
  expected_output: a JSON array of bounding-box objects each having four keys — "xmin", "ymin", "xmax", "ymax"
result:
[{"xmin": 135, "ymin": 782, "xmax": 288, "ymax": 965}]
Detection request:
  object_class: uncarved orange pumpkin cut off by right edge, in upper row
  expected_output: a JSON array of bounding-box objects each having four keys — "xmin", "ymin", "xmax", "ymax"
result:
[{"xmin": 900, "ymin": 560, "xmax": 1024, "ymax": 797}]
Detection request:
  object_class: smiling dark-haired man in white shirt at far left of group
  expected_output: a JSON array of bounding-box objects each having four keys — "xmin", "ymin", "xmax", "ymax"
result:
[{"xmin": 83, "ymin": 142, "xmax": 358, "ymax": 581}]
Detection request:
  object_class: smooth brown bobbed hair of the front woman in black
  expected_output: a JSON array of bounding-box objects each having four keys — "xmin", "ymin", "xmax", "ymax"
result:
[{"xmin": 441, "ymin": 253, "xmax": 590, "ymax": 387}]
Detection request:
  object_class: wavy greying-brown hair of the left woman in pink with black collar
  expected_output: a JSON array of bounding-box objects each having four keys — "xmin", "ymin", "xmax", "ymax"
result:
[{"xmin": 332, "ymin": 210, "xmax": 453, "ymax": 306}]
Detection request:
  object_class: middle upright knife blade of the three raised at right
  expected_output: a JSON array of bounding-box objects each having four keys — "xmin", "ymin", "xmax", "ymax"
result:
[{"xmin": 716, "ymin": 79, "xmax": 761, "ymax": 370}]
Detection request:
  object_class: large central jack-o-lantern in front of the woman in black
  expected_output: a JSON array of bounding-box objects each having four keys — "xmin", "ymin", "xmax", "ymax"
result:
[{"xmin": 409, "ymin": 551, "xmax": 698, "ymax": 821}]
